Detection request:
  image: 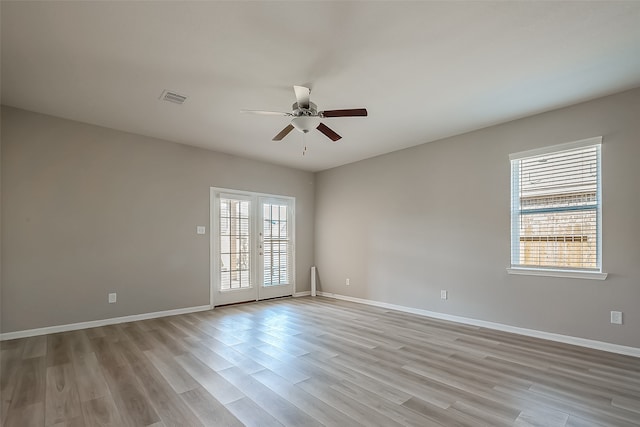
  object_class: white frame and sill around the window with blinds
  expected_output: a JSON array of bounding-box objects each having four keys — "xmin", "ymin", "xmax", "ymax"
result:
[{"xmin": 507, "ymin": 136, "xmax": 607, "ymax": 280}]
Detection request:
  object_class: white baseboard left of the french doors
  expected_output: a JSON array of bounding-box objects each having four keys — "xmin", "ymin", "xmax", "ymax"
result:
[{"xmin": 0, "ymin": 305, "xmax": 212, "ymax": 341}]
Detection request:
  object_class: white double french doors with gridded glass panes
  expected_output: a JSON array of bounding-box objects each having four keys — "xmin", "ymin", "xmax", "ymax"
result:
[{"xmin": 210, "ymin": 188, "xmax": 295, "ymax": 306}]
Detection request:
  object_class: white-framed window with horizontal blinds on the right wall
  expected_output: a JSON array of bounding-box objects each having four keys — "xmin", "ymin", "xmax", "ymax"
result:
[{"xmin": 509, "ymin": 137, "xmax": 606, "ymax": 279}]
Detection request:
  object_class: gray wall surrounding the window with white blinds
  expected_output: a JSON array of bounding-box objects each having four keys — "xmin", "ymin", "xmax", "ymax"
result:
[{"xmin": 315, "ymin": 89, "xmax": 640, "ymax": 347}]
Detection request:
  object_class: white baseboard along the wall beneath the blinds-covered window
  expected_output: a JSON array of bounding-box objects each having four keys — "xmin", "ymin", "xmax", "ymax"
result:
[{"xmin": 318, "ymin": 291, "xmax": 640, "ymax": 357}]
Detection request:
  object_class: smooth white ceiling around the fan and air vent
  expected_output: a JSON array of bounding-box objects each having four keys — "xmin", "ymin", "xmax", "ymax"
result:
[{"xmin": 1, "ymin": 1, "xmax": 640, "ymax": 171}]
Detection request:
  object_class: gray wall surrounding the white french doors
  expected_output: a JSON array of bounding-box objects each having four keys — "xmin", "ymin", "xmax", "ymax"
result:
[{"xmin": 1, "ymin": 107, "xmax": 314, "ymax": 332}]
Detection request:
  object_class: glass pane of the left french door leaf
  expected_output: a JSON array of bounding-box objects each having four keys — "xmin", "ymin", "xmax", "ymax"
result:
[{"xmin": 219, "ymin": 198, "xmax": 251, "ymax": 290}]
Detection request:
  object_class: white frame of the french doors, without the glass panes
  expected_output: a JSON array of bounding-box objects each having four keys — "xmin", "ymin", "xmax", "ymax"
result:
[{"xmin": 209, "ymin": 187, "xmax": 296, "ymax": 308}]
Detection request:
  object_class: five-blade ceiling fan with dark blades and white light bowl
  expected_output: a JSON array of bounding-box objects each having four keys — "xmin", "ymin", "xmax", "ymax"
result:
[{"xmin": 241, "ymin": 86, "xmax": 367, "ymax": 142}]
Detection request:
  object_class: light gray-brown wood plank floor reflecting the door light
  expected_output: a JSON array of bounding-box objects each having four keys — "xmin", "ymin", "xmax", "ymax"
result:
[{"xmin": 0, "ymin": 297, "xmax": 640, "ymax": 427}]
